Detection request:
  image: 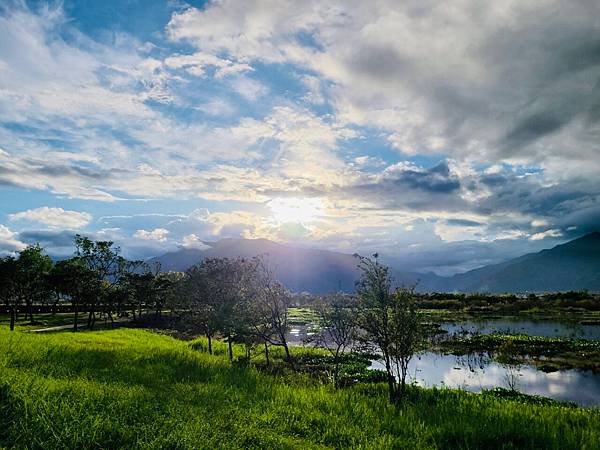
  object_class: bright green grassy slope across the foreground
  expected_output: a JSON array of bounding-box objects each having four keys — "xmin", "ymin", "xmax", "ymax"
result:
[{"xmin": 0, "ymin": 329, "xmax": 600, "ymax": 449}]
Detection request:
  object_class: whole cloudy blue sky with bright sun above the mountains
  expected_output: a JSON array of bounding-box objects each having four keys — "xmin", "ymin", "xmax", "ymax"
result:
[{"xmin": 0, "ymin": 0, "xmax": 600, "ymax": 275}]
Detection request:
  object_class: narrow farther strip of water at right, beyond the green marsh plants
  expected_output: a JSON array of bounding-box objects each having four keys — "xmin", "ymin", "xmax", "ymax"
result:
[{"xmin": 441, "ymin": 319, "xmax": 600, "ymax": 339}]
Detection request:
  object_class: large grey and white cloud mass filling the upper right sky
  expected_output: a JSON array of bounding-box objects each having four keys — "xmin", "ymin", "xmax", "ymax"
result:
[{"xmin": 168, "ymin": 0, "xmax": 600, "ymax": 174}]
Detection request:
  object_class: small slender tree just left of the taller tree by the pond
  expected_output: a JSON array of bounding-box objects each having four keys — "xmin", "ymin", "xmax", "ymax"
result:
[{"xmin": 310, "ymin": 294, "xmax": 358, "ymax": 388}]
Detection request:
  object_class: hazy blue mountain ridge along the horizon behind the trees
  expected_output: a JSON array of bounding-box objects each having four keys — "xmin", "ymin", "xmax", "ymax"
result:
[{"xmin": 150, "ymin": 232, "xmax": 600, "ymax": 294}]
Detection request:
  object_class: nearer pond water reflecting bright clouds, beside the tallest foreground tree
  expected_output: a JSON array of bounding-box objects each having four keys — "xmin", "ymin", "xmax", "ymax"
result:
[{"xmin": 371, "ymin": 352, "xmax": 600, "ymax": 406}]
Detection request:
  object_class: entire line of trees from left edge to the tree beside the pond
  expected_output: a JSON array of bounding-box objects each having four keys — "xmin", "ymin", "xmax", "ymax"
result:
[{"xmin": 0, "ymin": 235, "xmax": 424, "ymax": 402}]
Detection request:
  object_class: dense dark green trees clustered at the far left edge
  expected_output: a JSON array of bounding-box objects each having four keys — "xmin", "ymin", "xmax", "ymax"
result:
[{"xmin": 0, "ymin": 235, "xmax": 182, "ymax": 331}]
